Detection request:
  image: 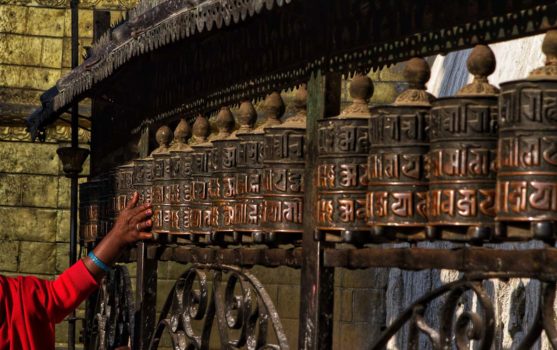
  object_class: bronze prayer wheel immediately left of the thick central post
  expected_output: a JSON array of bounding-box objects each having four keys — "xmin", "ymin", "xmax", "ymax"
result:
[{"xmin": 262, "ymin": 90, "xmax": 307, "ymax": 243}]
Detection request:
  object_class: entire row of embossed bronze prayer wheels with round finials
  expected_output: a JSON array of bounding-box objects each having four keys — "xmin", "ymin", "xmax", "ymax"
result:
[{"xmin": 82, "ymin": 31, "xmax": 557, "ymax": 243}]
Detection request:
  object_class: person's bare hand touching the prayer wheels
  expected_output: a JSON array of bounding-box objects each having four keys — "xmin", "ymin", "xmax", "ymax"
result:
[{"xmin": 107, "ymin": 192, "xmax": 153, "ymax": 247}]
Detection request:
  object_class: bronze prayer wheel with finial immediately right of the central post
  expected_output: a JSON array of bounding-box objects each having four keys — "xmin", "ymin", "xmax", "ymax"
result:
[{"xmin": 316, "ymin": 74, "xmax": 373, "ymax": 242}]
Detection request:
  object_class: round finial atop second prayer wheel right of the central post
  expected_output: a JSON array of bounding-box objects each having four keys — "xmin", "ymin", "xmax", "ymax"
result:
[{"xmin": 394, "ymin": 57, "xmax": 435, "ymax": 106}]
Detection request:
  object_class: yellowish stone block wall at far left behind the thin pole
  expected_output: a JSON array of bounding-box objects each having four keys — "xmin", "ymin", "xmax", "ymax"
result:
[{"xmin": 0, "ymin": 0, "xmax": 132, "ymax": 348}]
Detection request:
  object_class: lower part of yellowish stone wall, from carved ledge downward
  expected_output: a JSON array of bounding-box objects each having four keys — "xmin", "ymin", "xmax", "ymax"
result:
[{"xmin": 0, "ymin": 126, "xmax": 88, "ymax": 344}]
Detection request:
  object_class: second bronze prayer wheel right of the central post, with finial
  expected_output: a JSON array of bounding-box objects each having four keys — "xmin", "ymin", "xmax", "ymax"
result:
[{"xmin": 366, "ymin": 58, "xmax": 434, "ymax": 236}]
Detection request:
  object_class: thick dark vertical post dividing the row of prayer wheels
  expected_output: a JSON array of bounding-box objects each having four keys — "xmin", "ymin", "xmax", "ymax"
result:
[{"xmin": 298, "ymin": 72, "xmax": 340, "ymax": 350}]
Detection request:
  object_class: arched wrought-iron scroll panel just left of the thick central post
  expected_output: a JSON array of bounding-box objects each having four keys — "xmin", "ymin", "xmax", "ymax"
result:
[{"xmin": 149, "ymin": 264, "xmax": 289, "ymax": 350}]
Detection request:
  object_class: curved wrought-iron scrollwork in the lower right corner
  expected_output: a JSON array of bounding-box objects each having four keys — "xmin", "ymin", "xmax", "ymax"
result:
[{"xmin": 371, "ymin": 273, "xmax": 557, "ymax": 350}]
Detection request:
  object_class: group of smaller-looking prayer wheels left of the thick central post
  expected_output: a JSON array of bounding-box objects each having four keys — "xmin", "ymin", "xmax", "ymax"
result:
[{"xmin": 81, "ymin": 86, "xmax": 307, "ymax": 243}]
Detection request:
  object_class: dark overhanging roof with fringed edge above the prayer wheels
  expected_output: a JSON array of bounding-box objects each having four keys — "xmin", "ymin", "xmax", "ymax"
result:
[{"xmin": 27, "ymin": 0, "xmax": 557, "ymax": 142}]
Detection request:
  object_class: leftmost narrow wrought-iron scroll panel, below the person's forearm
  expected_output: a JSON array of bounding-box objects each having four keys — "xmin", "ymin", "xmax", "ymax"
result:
[{"xmin": 87, "ymin": 265, "xmax": 135, "ymax": 350}]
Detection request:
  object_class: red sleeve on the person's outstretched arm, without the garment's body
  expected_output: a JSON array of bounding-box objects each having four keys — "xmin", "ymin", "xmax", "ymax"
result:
[{"xmin": 25, "ymin": 260, "xmax": 98, "ymax": 323}]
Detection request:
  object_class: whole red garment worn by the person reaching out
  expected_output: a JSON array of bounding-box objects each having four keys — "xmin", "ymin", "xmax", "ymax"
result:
[{"xmin": 0, "ymin": 260, "xmax": 97, "ymax": 350}]
